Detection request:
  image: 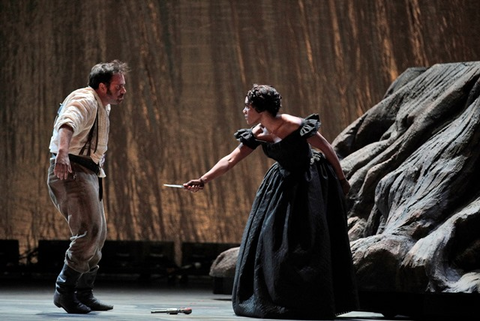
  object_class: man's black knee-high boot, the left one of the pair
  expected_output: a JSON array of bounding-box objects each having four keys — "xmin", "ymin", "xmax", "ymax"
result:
[{"xmin": 53, "ymin": 264, "xmax": 91, "ymax": 314}]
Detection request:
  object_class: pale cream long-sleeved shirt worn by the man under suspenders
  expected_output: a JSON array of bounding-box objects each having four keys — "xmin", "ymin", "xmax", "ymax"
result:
[{"xmin": 50, "ymin": 87, "xmax": 111, "ymax": 177}]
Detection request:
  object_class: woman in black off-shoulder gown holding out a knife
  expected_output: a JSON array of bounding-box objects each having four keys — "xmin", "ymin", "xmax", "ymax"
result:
[{"xmin": 184, "ymin": 85, "xmax": 357, "ymax": 319}]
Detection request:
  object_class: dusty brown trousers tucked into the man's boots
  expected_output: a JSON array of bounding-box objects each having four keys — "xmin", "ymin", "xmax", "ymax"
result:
[{"xmin": 47, "ymin": 158, "xmax": 107, "ymax": 273}]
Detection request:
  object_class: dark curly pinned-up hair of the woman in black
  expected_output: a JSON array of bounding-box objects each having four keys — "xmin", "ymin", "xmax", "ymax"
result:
[{"xmin": 247, "ymin": 84, "xmax": 282, "ymax": 116}]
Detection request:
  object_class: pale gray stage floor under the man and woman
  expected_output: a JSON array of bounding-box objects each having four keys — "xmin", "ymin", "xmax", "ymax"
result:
[{"xmin": 0, "ymin": 279, "xmax": 409, "ymax": 321}]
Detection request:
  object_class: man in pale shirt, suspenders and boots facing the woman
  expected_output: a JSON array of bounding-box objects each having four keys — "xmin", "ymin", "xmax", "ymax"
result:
[{"xmin": 48, "ymin": 60, "xmax": 128, "ymax": 313}]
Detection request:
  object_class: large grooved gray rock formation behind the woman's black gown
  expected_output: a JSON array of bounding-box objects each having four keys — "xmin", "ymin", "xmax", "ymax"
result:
[{"xmin": 333, "ymin": 62, "xmax": 480, "ymax": 294}]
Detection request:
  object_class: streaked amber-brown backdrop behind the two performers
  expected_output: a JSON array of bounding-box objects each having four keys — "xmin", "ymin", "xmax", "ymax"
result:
[{"xmin": 0, "ymin": 0, "xmax": 480, "ymax": 262}]
